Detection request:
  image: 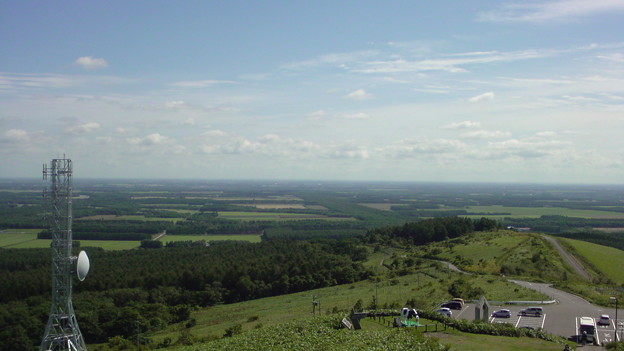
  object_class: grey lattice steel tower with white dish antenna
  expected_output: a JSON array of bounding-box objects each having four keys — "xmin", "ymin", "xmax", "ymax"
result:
[{"xmin": 39, "ymin": 156, "xmax": 88, "ymax": 351}]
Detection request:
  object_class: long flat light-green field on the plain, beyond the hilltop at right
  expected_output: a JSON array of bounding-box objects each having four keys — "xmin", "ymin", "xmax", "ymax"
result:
[{"xmin": 464, "ymin": 205, "xmax": 624, "ymax": 219}]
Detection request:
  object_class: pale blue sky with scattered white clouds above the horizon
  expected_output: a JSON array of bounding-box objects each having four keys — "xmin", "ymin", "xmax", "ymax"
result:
[{"xmin": 0, "ymin": 0, "xmax": 624, "ymax": 184}]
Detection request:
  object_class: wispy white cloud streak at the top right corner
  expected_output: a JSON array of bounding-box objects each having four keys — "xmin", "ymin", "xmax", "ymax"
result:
[{"xmin": 478, "ymin": 0, "xmax": 624, "ymax": 23}]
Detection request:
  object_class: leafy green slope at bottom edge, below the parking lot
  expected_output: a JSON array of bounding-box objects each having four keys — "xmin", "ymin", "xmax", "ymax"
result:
[{"xmin": 166, "ymin": 317, "xmax": 562, "ymax": 351}]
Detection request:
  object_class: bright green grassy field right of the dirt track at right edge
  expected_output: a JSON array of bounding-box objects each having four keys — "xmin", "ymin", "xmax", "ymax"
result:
[{"xmin": 558, "ymin": 238, "xmax": 624, "ymax": 284}]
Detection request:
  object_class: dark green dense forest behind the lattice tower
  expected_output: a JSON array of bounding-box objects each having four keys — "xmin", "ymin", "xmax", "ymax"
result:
[{"xmin": 0, "ymin": 240, "xmax": 370, "ymax": 350}]
